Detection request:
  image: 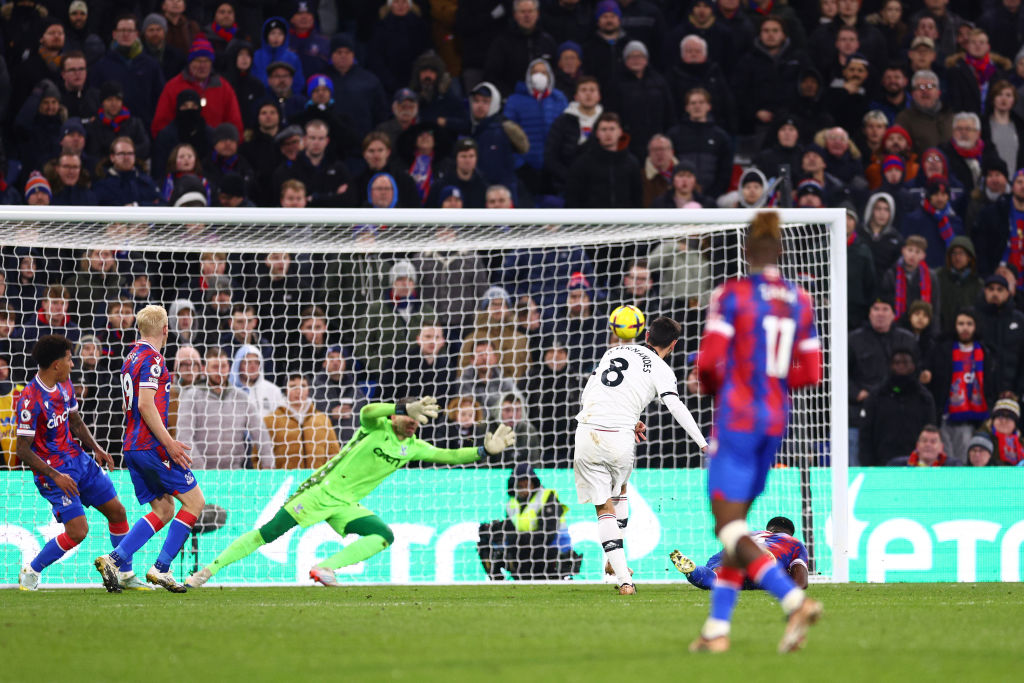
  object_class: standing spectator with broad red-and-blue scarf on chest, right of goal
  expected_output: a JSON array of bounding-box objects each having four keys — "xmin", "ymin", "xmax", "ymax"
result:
[{"xmin": 921, "ymin": 308, "xmax": 996, "ymax": 456}]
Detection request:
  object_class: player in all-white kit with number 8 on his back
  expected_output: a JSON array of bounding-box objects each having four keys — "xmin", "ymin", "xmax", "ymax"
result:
[{"xmin": 572, "ymin": 316, "xmax": 708, "ymax": 595}]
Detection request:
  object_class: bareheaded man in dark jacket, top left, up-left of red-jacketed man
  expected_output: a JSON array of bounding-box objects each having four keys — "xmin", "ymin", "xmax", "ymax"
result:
[{"xmin": 89, "ymin": 15, "xmax": 166, "ymax": 122}]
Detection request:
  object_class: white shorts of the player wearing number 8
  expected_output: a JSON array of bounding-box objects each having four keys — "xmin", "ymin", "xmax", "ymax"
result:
[{"xmin": 572, "ymin": 425, "xmax": 636, "ymax": 505}]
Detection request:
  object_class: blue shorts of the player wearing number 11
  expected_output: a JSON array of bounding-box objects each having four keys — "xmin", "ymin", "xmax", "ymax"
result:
[{"xmin": 708, "ymin": 429, "xmax": 782, "ymax": 503}]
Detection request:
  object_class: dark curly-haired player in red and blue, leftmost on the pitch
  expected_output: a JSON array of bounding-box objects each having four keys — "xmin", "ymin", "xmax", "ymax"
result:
[{"xmin": 16, "ymin": 335, "xmax": 138, "ymax": 592}]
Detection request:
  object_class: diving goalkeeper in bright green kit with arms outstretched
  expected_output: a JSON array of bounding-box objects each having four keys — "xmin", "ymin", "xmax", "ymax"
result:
[{"xmin": 185, "ymin": 396, "xmax": 515, "ymax": 588}]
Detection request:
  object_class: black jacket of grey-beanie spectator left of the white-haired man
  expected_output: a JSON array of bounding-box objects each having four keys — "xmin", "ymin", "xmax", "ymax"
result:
[{"xmin": 608, "ymin": 67, "xmax": 679, "ymax": 159}]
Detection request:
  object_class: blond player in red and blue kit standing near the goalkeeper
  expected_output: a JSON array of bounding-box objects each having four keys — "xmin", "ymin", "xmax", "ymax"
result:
[{"xmin": 95, "ymin": 305, "xmax": 206, "ymax": 593}]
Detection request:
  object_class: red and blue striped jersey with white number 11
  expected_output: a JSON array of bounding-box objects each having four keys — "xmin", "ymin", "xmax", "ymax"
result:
[{"xmin": 697, "ymin": 267, "xmax": 821, "ymax": 436}]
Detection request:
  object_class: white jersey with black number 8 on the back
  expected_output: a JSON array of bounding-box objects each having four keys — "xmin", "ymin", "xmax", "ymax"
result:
[{"xmin": 577, "ymin": 344, "xmax": 679, "ymax": 430}]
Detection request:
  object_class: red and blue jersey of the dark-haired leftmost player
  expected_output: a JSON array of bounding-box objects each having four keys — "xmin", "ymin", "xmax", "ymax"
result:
[{"xmin": 17, "ymin": 375, "xmax": 85, "ymax": 468}]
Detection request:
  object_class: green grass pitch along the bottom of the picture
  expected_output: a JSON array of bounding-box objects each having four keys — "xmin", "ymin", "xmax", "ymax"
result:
[{"xmin": 0, "ymin": 584, "xmax": 1024, "ymax": 683}]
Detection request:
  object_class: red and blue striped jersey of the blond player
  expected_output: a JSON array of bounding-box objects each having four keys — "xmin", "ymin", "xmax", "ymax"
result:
[{"xmin": 121, "ymin": 341, "xmax": 171, "ymax": 451}]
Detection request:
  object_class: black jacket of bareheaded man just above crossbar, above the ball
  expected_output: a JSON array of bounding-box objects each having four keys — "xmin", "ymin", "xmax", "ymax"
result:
[{"xmin": 565, "ymin": 136, "xmax": 643, "ymax": 209}]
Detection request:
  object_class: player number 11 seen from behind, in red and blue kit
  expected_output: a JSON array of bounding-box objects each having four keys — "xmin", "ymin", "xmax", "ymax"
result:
[{"xmin": 690, "ymin": 211, "xmax": 822, "ymax": 652}]
